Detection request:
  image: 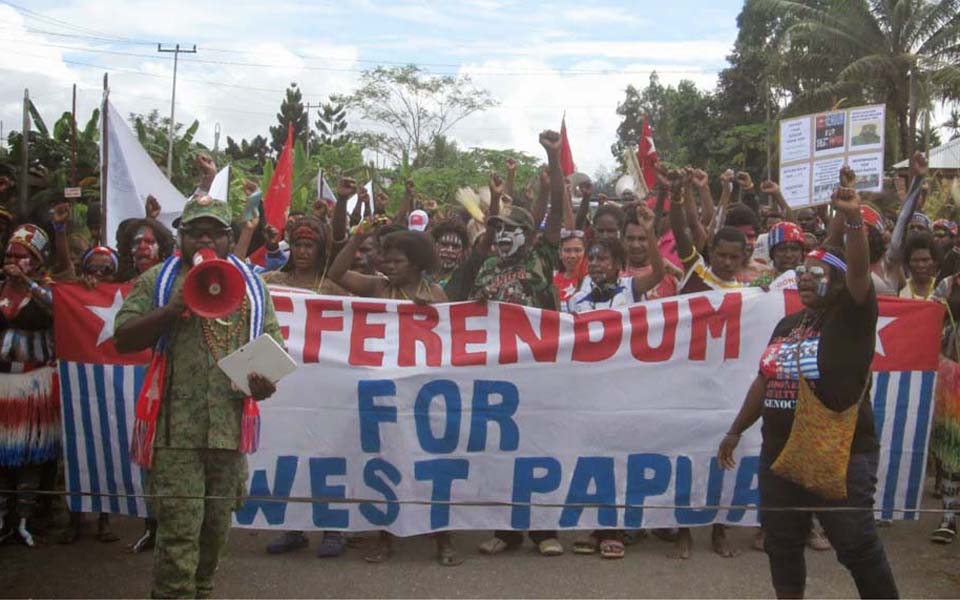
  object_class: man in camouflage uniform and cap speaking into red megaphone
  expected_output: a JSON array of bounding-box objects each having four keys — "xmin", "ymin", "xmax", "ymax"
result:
[{"xmin": 114, "ymin": 193, "xmax": 283, "ymax": 598}]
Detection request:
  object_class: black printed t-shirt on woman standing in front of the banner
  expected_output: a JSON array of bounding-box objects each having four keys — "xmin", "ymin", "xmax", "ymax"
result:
[{"xmin": 760, "ymin": 286, "xmax": 879, "ymax": 462}]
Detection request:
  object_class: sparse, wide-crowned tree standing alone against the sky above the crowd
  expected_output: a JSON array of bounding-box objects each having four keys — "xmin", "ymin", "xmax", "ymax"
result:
[{"xmin": 332, "ymin": 65, "xmax": 496, "ymax": 166}]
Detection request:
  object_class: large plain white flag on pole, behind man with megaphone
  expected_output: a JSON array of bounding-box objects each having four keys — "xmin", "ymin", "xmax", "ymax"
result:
[{"xmin": 100, "ymin": 100, "xmax": 187, "ymax": 246}]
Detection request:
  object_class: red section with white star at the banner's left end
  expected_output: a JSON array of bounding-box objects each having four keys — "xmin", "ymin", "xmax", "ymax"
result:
[{"xmin": 53, "ymin": 283, "xmax": 150, "ymax": 365}]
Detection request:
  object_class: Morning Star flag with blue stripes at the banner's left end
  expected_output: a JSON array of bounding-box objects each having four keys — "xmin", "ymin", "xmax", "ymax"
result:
[{"xmin": 53, "ymin": 283, "xmax": 150, "ymax": 517}]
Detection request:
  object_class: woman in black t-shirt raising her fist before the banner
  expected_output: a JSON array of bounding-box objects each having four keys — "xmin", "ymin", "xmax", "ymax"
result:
[{"xmin": 717, "ymin": 184, "xmax": 898, "ymax": 598}]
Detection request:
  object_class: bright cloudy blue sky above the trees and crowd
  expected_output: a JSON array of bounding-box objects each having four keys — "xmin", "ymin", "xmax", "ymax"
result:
[{"xmin": 0, "ymin": 0, "xmax": 742, "ymax": 173}]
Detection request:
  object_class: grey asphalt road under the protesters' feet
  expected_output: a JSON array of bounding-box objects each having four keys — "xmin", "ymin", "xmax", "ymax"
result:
[{"xmin": 0, "ymin": 497, "xmax": 960, "ymax": 598}]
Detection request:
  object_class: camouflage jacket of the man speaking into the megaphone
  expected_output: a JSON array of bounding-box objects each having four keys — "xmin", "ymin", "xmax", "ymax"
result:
[{"xmin": 114, "ymin": 265, "xmax": 283, "ymax": 450}]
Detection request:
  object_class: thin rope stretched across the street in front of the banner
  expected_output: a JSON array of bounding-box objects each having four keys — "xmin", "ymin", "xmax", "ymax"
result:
[{"xmin": 0, "ymin": 489, "xmax": 960, "ymax": 514}]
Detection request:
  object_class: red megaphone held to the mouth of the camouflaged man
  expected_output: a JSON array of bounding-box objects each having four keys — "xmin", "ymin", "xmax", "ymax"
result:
[{"xmin": 183, "ymin": 248, "xmax": 247, "ymax": 319}]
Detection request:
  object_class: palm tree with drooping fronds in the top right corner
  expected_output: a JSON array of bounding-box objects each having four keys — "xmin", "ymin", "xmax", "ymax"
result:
[{"xmin": 755, "ymin": 0, "xmax": 960, "ymax": 161}]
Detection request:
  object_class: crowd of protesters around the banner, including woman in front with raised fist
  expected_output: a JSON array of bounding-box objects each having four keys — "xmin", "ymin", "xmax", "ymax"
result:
[{"xmin": 0, "ymin": 124, "xmax": 960, "ymax": 597}]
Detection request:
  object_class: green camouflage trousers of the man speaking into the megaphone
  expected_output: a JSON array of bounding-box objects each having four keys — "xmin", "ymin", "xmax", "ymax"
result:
[{"xmin": 149, "ymin": 448, "xmax": 247, "ymax": 598}]
